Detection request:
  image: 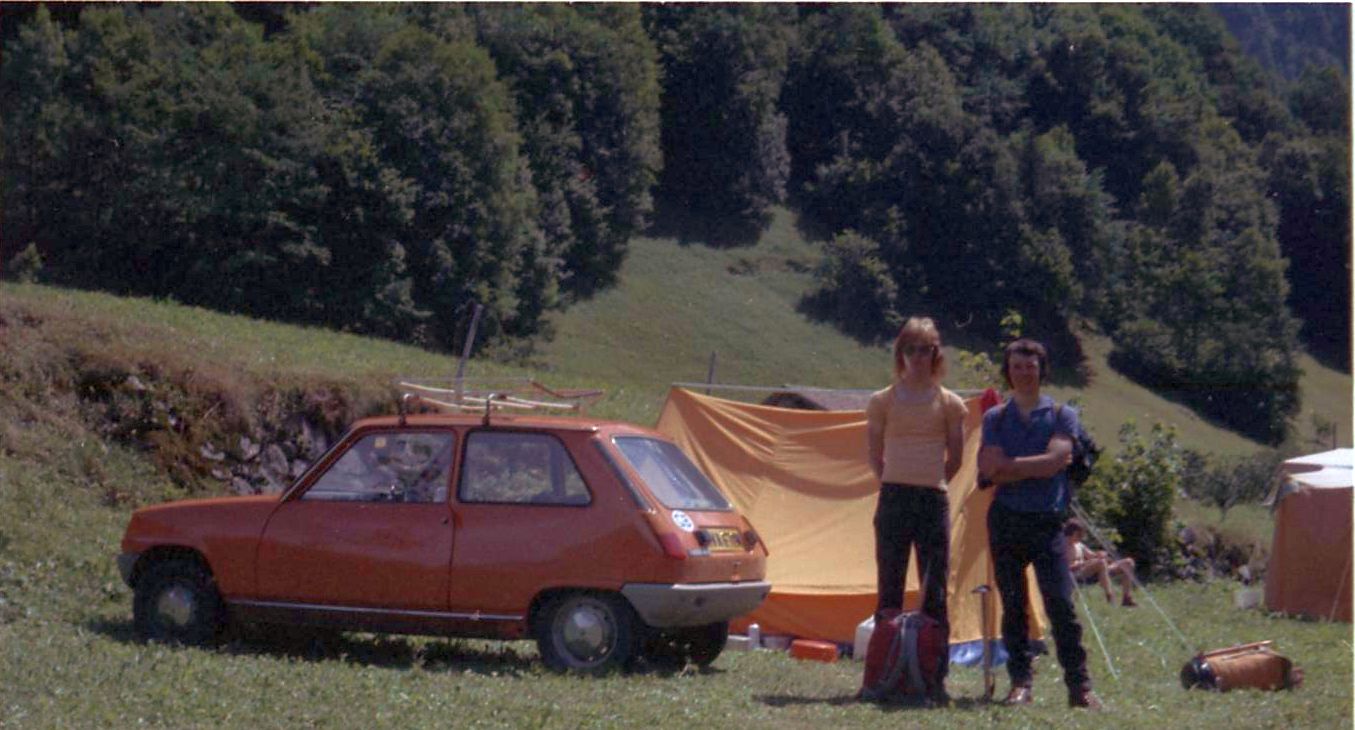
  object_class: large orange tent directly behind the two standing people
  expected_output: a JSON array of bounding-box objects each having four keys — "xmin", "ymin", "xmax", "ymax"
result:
[{"xmin": 656, "ymin": 387, "xmax": 1045, "ymax": 643}]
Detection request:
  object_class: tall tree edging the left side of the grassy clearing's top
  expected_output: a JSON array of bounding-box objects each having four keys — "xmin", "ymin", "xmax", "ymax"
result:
[{"xmin": 473, "ymin": 5, "xmax": 661, "ymax": 295}]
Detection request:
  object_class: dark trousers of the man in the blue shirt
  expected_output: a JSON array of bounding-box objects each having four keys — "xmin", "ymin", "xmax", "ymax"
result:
[{"xmin": 988, "ymin": 502, "xmax": 1091, "ymax": 692}]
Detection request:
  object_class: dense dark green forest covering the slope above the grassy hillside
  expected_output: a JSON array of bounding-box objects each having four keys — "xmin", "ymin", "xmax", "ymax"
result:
[{"xmin": 0, "ymin": 3, "xmax": 1351, "ymax": 443}]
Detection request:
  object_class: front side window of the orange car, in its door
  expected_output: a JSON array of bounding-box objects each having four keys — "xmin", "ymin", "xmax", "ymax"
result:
[{"xmin": 301, "ymin": 432, "xmax": 455, "ymax": 502}]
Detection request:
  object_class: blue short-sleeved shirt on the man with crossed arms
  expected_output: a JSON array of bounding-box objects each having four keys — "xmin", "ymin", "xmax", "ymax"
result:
[{"xmin": 984, "ymin": 395, "xmax": 1077, "ymax": 512}]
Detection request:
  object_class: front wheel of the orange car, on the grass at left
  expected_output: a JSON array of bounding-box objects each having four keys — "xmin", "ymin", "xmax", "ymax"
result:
[{"xmin": 131, "ymin": 558, "xmax": 225, "ymax": 646}]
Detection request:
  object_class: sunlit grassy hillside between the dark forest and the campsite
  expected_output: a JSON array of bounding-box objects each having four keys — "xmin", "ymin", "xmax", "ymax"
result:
[{"xmin": 0, "ymin": 210, "xmax": 1351, "ymax": 454}]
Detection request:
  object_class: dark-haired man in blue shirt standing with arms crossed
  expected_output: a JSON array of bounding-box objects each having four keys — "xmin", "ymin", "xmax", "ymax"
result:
[{"xmin": 978, "ymin": 339, "xmax": 1102, "ymax": 710}]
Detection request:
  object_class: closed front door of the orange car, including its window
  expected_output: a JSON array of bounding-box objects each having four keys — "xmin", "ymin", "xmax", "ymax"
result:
[{"xmin": 256, "ymin": 429, "xmax": 455, "ymax": 611}]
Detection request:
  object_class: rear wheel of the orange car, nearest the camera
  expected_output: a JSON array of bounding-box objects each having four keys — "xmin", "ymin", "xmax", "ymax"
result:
[{"xmin": 537, "ymin": 592, "xmax": 638, "ymax": 674}]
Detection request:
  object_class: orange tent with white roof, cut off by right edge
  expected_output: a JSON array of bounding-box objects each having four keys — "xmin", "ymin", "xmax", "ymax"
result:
[{"xmin": 1266, "ymin": 448, "xmax": 1355, "ymax": 623}]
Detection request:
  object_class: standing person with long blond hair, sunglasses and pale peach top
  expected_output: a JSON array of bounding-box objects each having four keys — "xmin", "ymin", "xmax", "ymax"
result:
[{"xmin": 866, "ymin": 317, "xmax": 966, "ymax": 700}]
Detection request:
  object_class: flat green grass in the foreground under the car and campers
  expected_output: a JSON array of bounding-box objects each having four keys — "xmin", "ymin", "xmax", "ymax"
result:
[{"xmin": 0, "ymin": 448, "xmax": 1352, "ymax": 729}]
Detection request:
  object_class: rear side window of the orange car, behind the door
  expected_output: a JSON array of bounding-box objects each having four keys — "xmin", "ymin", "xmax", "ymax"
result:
[{"xmin": 457, "ymin": 431, "xmax": 592, "ymax": 507}]
